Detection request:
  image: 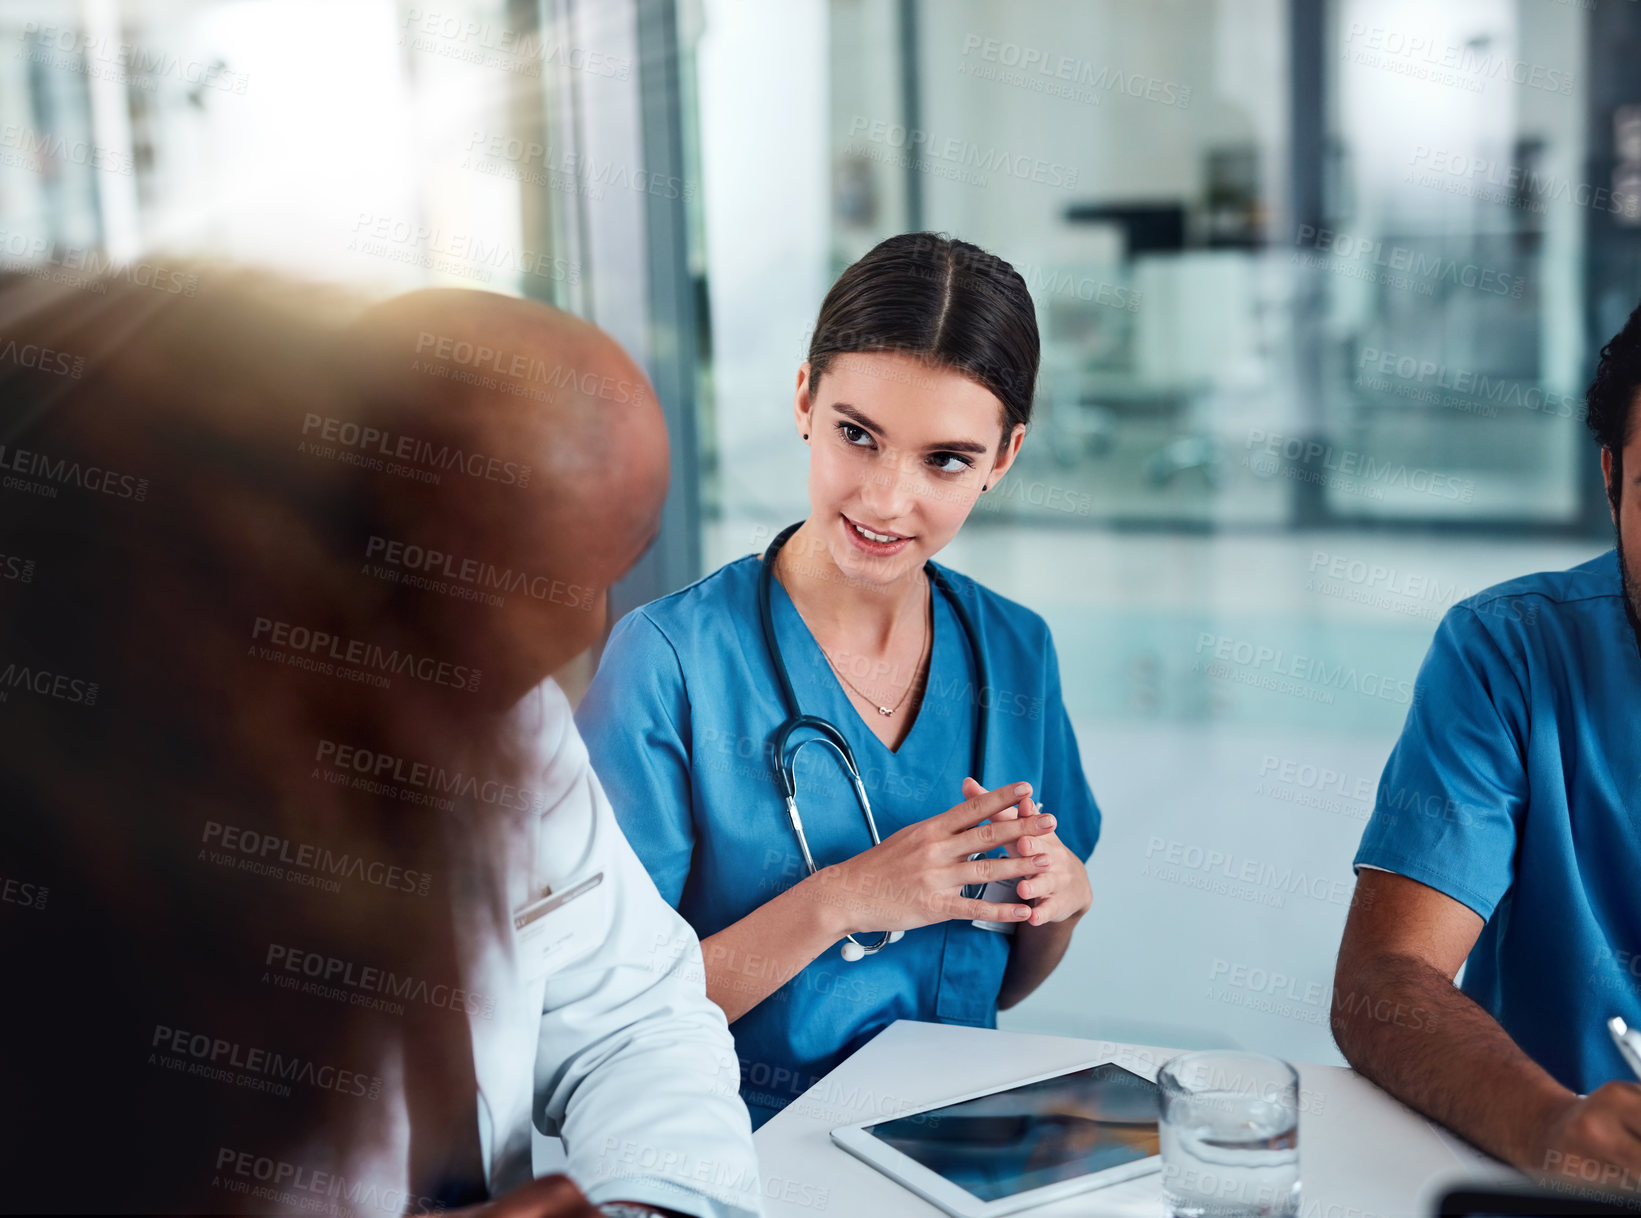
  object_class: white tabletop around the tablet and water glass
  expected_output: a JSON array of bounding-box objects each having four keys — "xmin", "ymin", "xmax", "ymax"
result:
[{"xmin": 755, "ymin": 1019, "xmax": 1516, "ymax": 1218}]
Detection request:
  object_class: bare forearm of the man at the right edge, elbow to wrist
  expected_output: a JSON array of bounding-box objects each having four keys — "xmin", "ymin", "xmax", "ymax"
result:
[{"xmin": 1332, "ymin": 955, "xmax": 1575, "ymax": 1170}]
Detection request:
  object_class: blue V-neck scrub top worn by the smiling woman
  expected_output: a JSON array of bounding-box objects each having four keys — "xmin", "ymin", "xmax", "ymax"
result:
[{"xmin": 576, "ymin": 556, "xmax": 1099, "ymax": 1124}]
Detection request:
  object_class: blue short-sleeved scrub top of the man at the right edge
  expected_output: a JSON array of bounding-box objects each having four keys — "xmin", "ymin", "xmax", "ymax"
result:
[{"xmin": 1355, "ymin": 552, "xmax": 1641, "ymax": 1093}]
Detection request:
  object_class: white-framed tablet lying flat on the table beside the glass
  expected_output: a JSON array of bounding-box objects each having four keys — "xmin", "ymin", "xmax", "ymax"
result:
[{"xmin": 832, "ymin": 1060, "xmax": 1162, "ymax": 1218}]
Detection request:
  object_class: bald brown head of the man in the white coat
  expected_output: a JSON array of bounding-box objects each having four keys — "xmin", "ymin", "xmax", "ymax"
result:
[{"xmin": 343, "ymin": 289, "xmax": 668, "ymax": 706}]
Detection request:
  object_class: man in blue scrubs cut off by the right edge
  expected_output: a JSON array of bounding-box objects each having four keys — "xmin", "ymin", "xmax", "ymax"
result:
[{"xmin": 1332, "ymin": 300, "xmax": 1641, "ymax": 1190}]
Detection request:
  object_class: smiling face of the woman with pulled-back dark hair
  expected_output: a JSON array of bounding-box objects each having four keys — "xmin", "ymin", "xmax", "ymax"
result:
[{"xmin": 793, "ymin": 351, "xmax": 1026, "ymax": 584}]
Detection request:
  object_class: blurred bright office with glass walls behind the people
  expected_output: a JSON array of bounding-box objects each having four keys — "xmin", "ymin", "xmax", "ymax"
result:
[{"xmin": 12, "ymin": 0, "xmax": 1641, "ymax": 1062}]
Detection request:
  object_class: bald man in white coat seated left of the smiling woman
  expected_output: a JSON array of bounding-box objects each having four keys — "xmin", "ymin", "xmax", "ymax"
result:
[{"xmin": 354, "ymin": 291, "xmax": 761, "ymax": 1218}]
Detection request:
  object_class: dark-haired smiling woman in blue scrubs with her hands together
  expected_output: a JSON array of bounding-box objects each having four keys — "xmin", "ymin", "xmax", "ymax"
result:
[{"xmin": 576, "ymin": 233, "xmax": 1099, "ymax": 1124}]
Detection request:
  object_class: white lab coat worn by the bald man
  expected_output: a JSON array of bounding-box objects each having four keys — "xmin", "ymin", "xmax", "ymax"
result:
[{"xmin": 456, "ymin": 681, "xmax": 761, "ymax": 1218}]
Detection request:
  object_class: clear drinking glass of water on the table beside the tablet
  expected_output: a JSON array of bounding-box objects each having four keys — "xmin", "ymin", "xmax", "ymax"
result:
[{"xmin": 1157, "ymin": 1049, "xmax": 1300, "ymax": 1218}]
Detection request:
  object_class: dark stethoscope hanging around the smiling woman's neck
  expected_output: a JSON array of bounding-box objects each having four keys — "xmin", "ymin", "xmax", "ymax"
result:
[{"xmin": 758, "ymin": 520, "xmax": 988, "ymax": 960}]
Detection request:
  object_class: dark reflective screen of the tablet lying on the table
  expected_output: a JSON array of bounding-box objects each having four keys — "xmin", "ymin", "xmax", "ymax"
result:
[{"xmin": 866, "ymin": 1062, "xmax": 1159, "ymax": 1202}]
